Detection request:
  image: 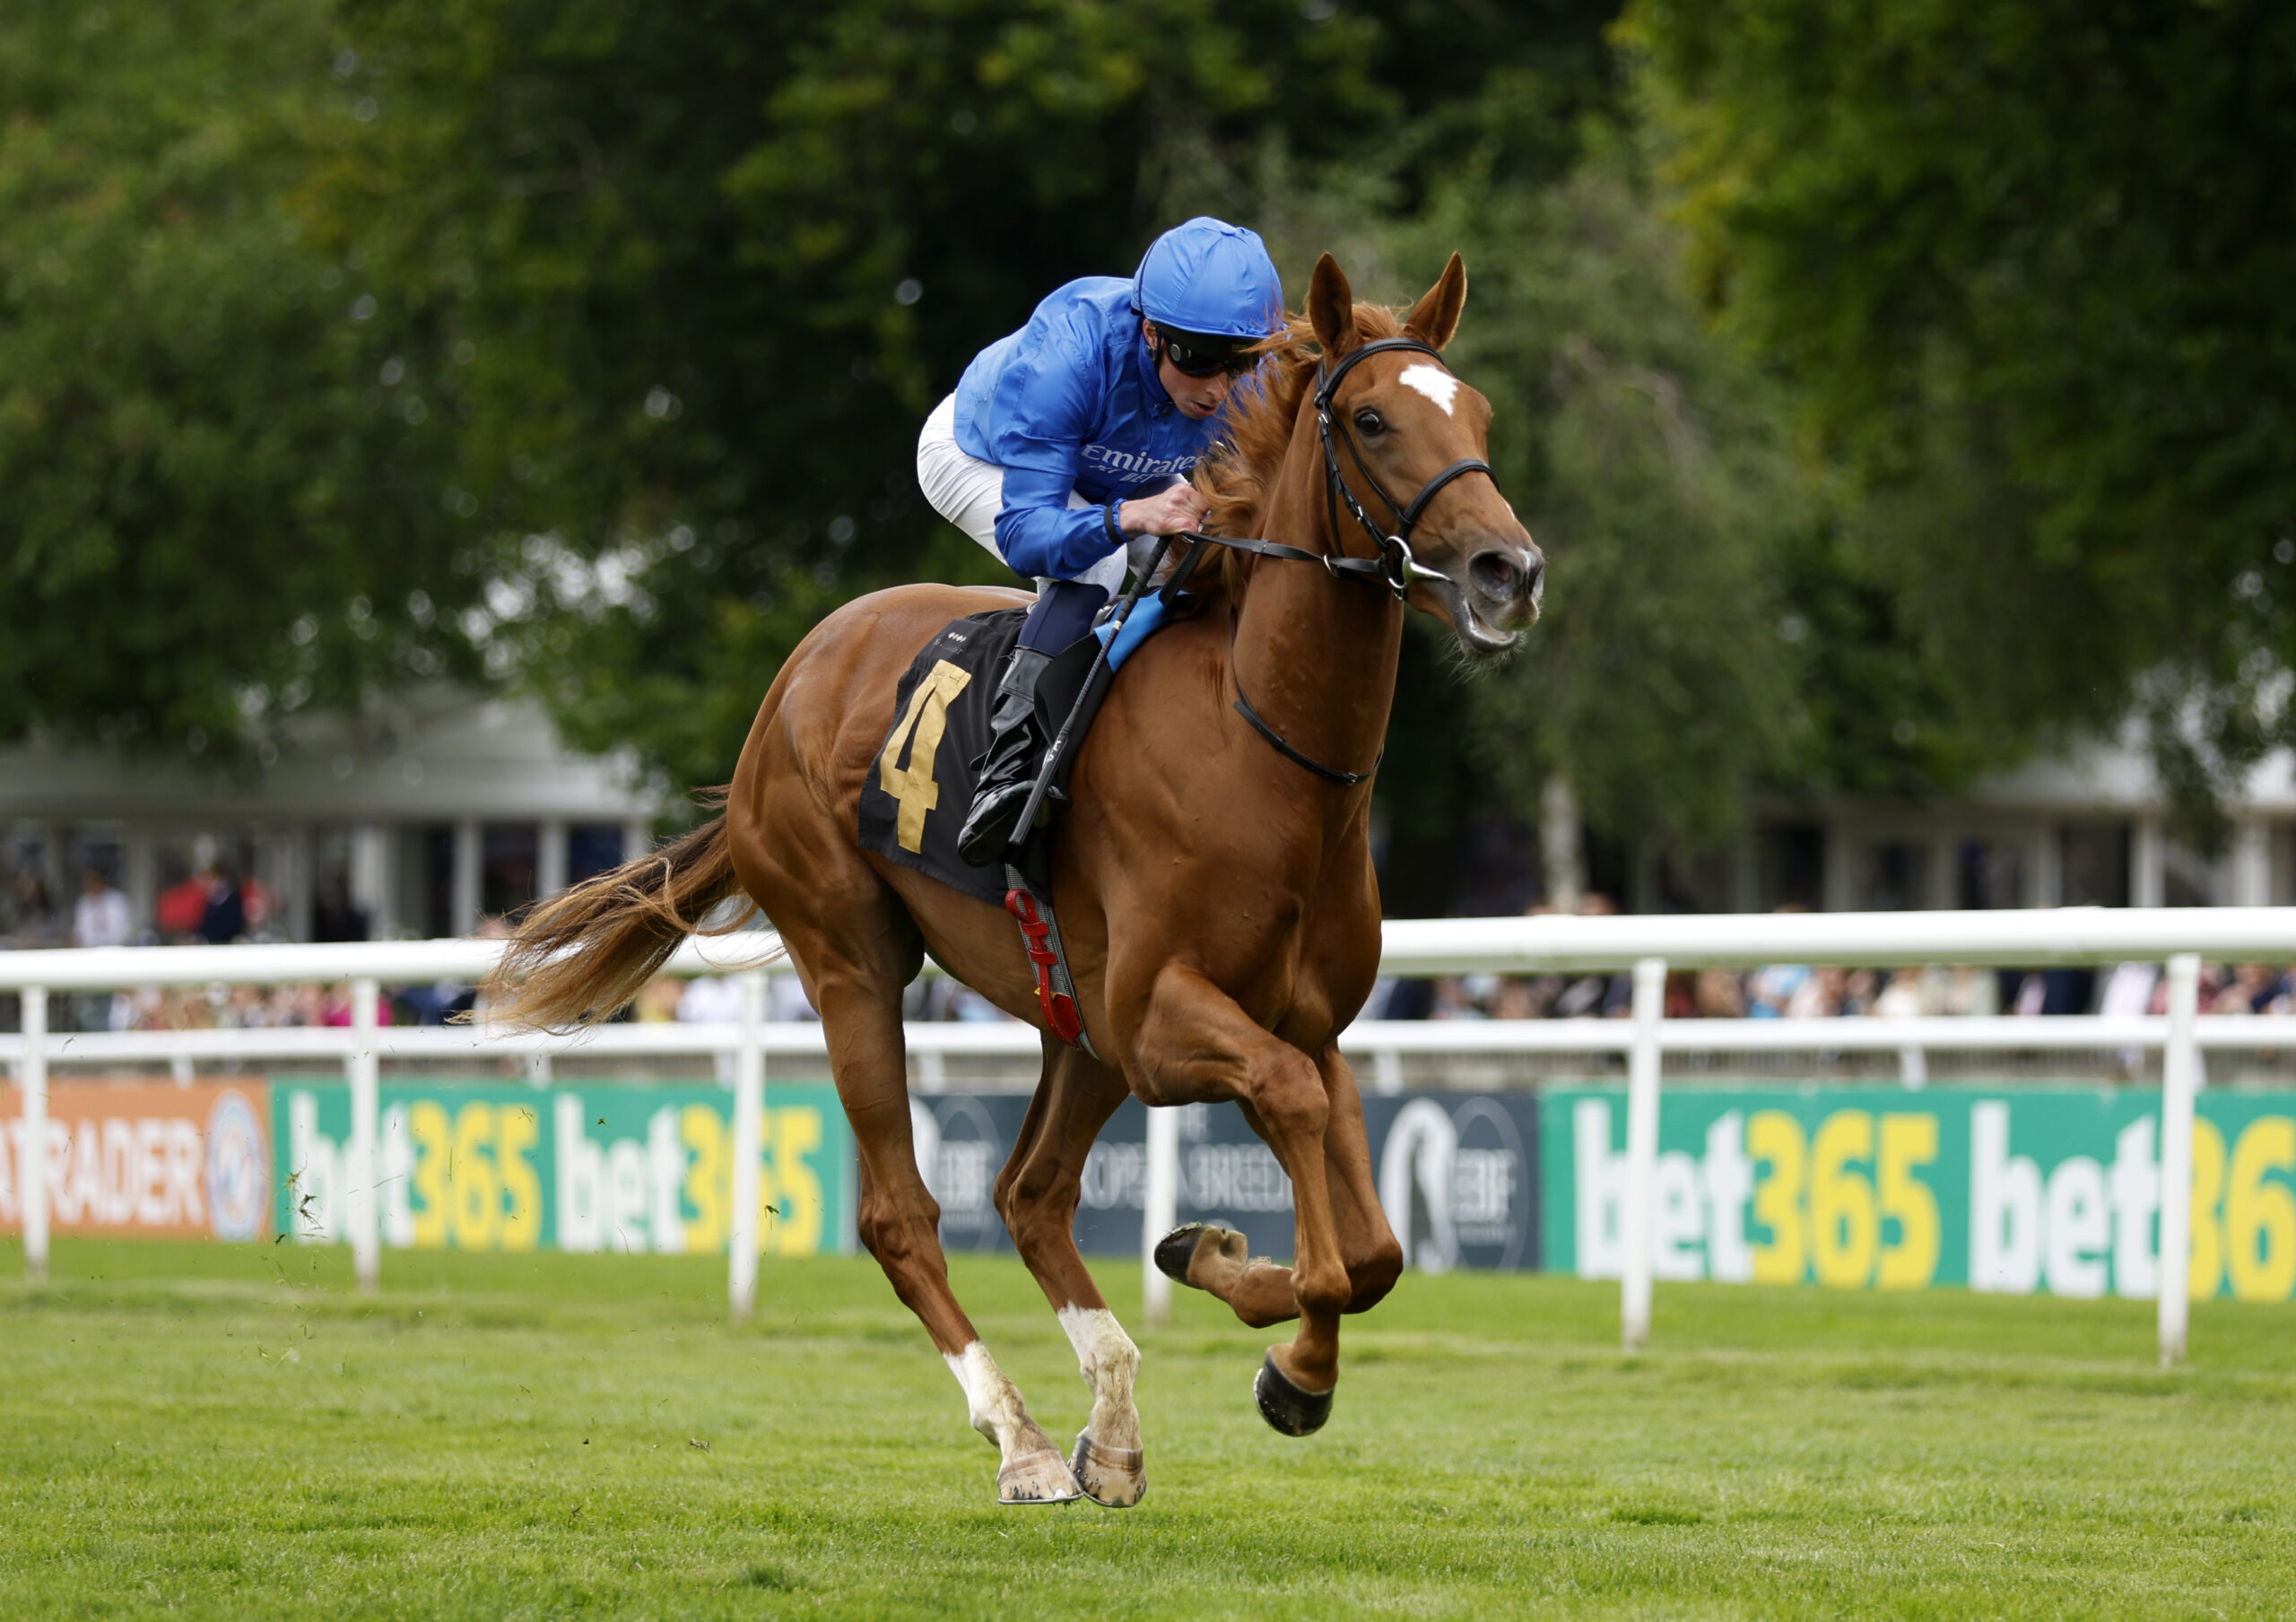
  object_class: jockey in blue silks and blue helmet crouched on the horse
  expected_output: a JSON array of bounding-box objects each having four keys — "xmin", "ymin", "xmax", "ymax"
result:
[{"xmin": 916, "ymin": 218, "xmax": 1283, "ymax": 865}]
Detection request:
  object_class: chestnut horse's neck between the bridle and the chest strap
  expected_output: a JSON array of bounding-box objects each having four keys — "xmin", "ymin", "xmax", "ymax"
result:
[{"xmin": 1233, "ymin": 411, "xmax": 1403, "ymax": 771}]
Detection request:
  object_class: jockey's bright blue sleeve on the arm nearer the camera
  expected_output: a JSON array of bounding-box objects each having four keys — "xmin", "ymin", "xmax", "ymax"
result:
[{"xmin": 989, "ymin": 321, "xmax": 1116, "ymax": 580}]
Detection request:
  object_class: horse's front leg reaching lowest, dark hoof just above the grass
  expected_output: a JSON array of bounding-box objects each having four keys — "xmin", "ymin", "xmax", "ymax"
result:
[{"xmin": 1132, "ymin": 966, "xmax": 1352, "ymax": 1434}]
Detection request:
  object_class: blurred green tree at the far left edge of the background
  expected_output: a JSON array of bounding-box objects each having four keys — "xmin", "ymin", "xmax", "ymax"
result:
[{"xmin": 0, "ymin": 0, "xmax": 473, "ymax": 759}]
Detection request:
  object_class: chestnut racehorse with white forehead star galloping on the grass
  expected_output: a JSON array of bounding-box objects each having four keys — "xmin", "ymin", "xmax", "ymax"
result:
[{"xmin": 496, "ymin": 255, "xmax": 1543, "ymax": 1505}]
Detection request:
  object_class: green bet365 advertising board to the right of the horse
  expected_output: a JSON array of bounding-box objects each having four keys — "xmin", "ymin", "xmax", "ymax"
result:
[{"xmin": 1541, "ymin": 1088, "xmax": 2296, "ymax": 1301}]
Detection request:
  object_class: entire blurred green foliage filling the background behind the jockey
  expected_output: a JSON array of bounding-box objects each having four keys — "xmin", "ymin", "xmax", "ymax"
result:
[{"xmin": 27, "ymin": 0, "xmax": 2195, "ymax": 880}]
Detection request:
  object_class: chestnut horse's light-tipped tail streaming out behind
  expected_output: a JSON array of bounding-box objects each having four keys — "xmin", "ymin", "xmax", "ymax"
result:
[{"xmin": 487, "ymin": 792, "xmax": 755, "ymax": 1026}]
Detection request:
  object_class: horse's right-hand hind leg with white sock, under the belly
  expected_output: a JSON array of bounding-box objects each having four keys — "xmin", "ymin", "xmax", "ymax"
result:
[{"xmin": 996, "ymin": 1037, "xmax": 1148, "ymax": 1510}]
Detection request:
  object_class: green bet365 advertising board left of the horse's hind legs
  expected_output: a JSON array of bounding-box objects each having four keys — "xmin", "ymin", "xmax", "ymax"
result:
[{"xmin": 271, "ymin": 1080, "xmax": 854, "ymax": 1255}]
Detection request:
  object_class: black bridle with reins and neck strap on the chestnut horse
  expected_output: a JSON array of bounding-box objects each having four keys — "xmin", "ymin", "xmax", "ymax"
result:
[{"xmin": 1148, "ymin": 337, "xmax": 1500, "ymax": 789}]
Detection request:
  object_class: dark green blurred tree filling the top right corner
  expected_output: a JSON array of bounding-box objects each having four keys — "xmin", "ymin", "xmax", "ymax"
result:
[{"xmin": 1625, "ymin": 0, "xmax": 2296, "ymax": 839}]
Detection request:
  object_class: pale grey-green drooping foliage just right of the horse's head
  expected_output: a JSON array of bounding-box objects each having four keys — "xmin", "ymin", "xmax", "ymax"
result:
[{"xmin": 1272, "ymin": 149, "xmax": 1821, "ymax": 863}]
